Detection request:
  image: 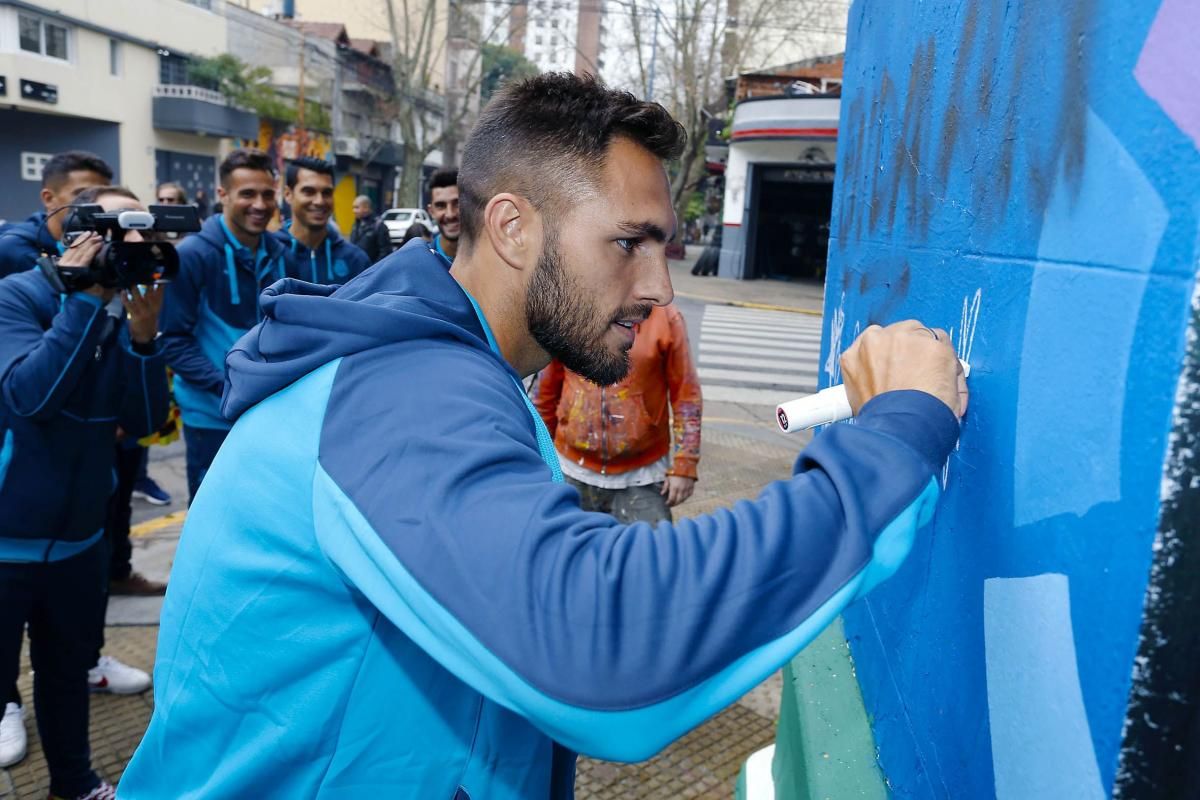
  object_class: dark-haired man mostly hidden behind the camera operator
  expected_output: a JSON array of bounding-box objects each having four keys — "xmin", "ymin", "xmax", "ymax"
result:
[{"xmin": 0, "ymin": 150, "xmax": 113, "ymax": 278}]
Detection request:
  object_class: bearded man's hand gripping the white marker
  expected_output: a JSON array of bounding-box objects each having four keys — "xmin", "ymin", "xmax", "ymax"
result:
[{"xmin": 841, "ymin": 319, "xmax": 967, "ymax": 417}]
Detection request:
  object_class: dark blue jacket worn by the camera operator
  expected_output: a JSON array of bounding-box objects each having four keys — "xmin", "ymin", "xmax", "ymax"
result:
[{"xmin": 0, "ymin": 270, "xmax": 167, "ymax": 561}]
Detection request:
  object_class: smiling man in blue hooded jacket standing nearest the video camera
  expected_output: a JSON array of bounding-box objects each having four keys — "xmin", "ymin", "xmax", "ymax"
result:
[{"xmin": 162, "ymin": 150, "xmax": 288, "ymax": 498}]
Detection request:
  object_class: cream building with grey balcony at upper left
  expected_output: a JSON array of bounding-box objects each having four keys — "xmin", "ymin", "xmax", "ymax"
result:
[{"xmin": 0, "ymin": 0, "xmax": 247, "ymax": 219}]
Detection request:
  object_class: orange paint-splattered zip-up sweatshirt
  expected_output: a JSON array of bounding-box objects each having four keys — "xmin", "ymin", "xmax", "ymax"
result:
[{"xmin": 535, "ymin": 305, "xmax": 701, "ymax": 477}]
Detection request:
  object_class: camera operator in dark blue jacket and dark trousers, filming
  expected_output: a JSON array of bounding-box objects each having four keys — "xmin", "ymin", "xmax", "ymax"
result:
[{"xmin": 0, "ymin": 187, "xmax": 167, "ymax": 800}]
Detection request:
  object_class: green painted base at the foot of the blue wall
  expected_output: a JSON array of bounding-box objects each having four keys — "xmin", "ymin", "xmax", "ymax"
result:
[{"xmin": 737, "ymin": 616, "xmax": 888, "ymax": 800}]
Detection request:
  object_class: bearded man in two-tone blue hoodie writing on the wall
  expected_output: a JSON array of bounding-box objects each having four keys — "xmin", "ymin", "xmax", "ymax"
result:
[{"xmin": 120, "ymin": 74, "xmax": 962, "ymax": 800}]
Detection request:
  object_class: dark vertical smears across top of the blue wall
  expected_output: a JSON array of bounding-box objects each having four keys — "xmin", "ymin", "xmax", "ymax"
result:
[{"xmin": 838, "ymin": 0, "xmax": 1097, "ymax": 248}]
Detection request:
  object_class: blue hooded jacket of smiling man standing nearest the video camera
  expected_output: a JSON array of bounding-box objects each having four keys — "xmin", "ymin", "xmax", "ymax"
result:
[{"xmin": 162, "ymin": 215, "xmax": 288, "ymax": 431}]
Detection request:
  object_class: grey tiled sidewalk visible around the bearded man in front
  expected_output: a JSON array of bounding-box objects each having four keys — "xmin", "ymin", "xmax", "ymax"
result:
[{"xmin": 0, "ymin": 424, "xmax": 808, "ymax": 800}]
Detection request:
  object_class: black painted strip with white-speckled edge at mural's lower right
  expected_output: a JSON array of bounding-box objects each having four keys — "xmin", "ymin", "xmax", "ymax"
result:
[{"xmin": 1112, "ymin": 303, "xmax": 1200, "ymax": 800}]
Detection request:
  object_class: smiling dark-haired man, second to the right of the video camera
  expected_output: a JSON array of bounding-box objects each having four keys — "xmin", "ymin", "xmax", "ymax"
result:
[{"xmin": 275, "ymin": 157, "xmax": 371, "ymax": 285}]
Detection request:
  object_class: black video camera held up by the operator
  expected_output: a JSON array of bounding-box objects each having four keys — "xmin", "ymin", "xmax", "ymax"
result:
[{"xmin": 38, "ymin": 204, "xmax": 200, "ymax": 293}]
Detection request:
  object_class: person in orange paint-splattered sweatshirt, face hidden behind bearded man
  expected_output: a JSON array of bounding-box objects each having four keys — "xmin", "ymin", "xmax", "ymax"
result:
[{"xmin": 534, "ymin": 305, "xmax": 701, "ymax": 523}]
